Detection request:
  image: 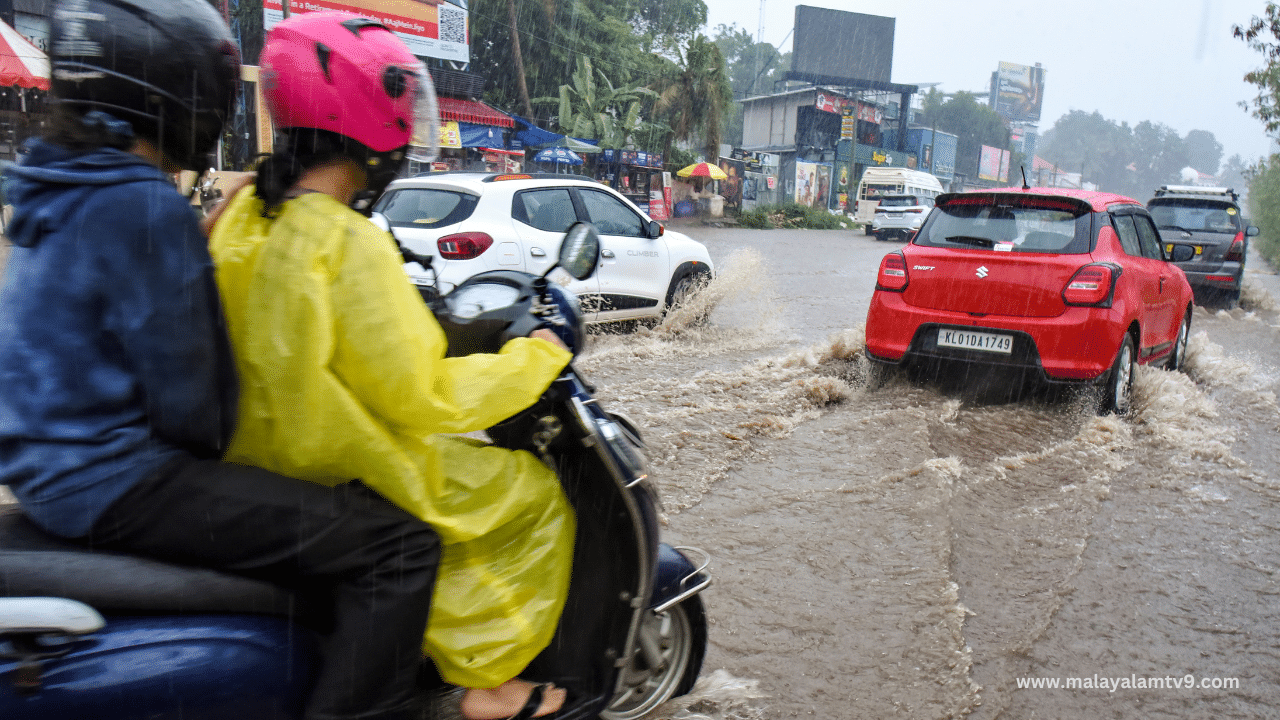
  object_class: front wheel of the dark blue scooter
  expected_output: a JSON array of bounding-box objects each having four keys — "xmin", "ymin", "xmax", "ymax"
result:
[{"xmin": 600, "ymin": 596, "xmax": 707, "ymax": 720}]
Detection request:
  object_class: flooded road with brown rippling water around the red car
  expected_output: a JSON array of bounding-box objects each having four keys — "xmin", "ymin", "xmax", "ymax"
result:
[{"xmin": 580, "ymin": 227, "xmax": 1280, "ymax": 719}]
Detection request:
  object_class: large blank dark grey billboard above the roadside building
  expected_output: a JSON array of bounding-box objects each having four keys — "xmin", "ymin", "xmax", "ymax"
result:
[{"xmin": 791, "ymin": 5, "xmax": 895, "ymax": 82}]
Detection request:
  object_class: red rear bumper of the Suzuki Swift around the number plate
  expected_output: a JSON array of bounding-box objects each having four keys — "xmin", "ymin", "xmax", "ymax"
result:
[{"xmin": 867, "ymin": 291, "xmax": 1125, "ymax": 382}]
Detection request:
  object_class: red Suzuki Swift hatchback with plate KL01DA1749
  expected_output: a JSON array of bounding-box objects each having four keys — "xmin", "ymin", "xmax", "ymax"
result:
[{"xmin": 867, "ymin": 187, "xmax": 1192, "ymax": 414}]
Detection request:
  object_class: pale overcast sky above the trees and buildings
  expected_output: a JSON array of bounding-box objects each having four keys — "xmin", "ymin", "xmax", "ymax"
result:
[{"xmin": 705, "ymin": 0, "xmax": 1270, "ymax": 161}]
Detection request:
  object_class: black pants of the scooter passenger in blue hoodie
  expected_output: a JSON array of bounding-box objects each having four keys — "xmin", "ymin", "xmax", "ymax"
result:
[{"xmin": 86, "ymin": 460, "xmax": 440, "ymax": 720}]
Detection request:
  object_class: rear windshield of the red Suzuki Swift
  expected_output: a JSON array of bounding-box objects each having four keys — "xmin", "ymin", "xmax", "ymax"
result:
[{"xmin": 914, "ymin": 197, "xmax": 1091, "ymax": 254}]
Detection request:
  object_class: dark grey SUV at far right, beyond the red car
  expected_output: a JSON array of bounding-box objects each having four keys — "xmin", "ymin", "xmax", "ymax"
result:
[{"xmin": 1147, "ymin": 184, "xmax": 1258, "ymax": 307}]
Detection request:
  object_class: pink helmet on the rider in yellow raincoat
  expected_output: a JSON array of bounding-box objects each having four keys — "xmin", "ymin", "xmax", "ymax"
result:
[{"xmin": 261, "ymin": 12, "xmax": 438, "ymax": 155}]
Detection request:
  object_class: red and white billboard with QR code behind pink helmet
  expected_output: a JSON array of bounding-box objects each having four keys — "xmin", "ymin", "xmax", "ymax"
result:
[{"xmin": 262, "ymin": 0, "xmax": 471, "ymax": 63}]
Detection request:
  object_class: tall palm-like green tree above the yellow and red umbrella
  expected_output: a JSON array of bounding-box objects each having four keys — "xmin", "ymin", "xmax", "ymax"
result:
[{"xmin": 653, "ymin": 35, "xmax": 733, "ymax": 163}]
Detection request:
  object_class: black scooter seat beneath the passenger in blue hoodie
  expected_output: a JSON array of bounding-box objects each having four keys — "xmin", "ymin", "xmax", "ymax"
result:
[{"xmin": 0, "ymin": 505, "xmax": 297, "ymax": 615}]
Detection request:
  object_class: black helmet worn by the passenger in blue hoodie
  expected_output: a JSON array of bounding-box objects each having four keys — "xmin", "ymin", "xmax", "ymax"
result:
[{"xmin": 49, "ymin": 0, "xmax": 239, "ymax": 170}]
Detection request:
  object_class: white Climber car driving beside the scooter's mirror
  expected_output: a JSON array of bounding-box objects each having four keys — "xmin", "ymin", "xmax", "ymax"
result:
[{"xmin": 372, "ymin": 172, "xmax": 713, "ymax": 323}]
